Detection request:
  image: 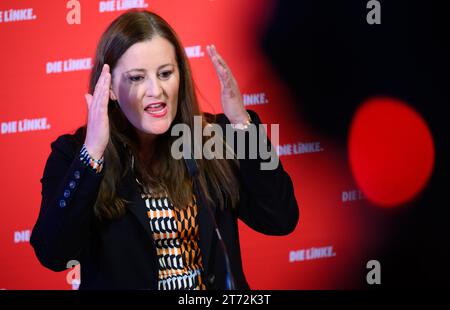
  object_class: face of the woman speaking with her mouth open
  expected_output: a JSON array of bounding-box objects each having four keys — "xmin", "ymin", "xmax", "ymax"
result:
[{"xmin": 110, "ymin": 36, "xmax": 180, "ymax": 139}]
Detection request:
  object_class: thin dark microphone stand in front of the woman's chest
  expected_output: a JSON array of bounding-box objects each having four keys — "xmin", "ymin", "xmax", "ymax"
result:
[{"xmin": 184, "ymin": 156, "xmax": 236, "ymax": 290}]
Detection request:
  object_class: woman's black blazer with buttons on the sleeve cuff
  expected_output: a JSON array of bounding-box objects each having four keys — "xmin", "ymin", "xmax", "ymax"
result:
[{"xmin": 30, "ymin": 111, "xmax": 299, "ymax": 289}]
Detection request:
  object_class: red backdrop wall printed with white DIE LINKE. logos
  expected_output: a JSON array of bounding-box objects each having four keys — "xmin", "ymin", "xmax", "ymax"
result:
[{"xmin": 0, "ymin": 0, "xmax": 422, "ymax": 289}]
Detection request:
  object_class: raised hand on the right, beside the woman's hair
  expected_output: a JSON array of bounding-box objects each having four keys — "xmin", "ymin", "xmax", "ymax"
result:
[{"xmin": 206, "ymin": 45, "xmax": 248, "ymax": 124}]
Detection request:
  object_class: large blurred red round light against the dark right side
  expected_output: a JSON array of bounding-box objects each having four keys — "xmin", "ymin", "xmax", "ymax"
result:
[{"xmin": 348, "ymin": 97, "xmax": 434, "ymax": 207}]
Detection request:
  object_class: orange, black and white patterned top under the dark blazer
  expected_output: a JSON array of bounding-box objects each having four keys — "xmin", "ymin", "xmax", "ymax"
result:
[{"xmin": 142, "ymin": 194, "xmax": 206, "ymax": 290}]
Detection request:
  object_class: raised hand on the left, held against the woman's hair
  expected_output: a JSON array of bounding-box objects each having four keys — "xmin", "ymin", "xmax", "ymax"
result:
[{"xmin": 84, "ymin": 64, "xmax": 111, "ymax": 159}]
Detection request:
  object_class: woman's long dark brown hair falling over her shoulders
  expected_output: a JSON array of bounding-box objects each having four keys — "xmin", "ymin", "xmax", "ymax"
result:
[{"xmin": 89, "ymin": 10, "xmax": 243, "ymax": 219}]
